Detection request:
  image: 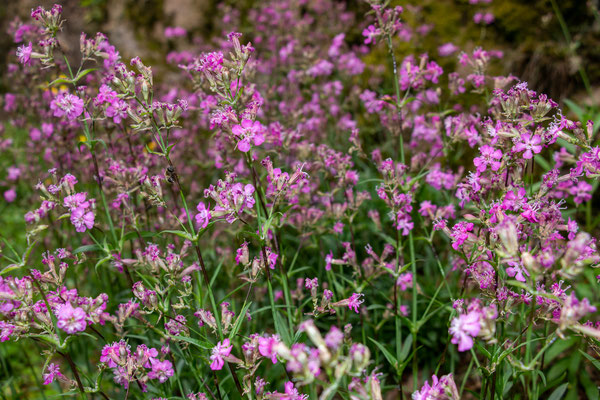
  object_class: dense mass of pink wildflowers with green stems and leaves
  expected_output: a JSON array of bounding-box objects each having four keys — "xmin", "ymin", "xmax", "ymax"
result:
[{"xmin": 0, "ymin": 0, "xmax": 600, "ymax": 400}]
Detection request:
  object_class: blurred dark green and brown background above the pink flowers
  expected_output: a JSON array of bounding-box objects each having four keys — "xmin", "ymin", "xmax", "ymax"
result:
[{"xmin": 0, "ymin": 0, "xmax": 600, "ymax": 104}]
